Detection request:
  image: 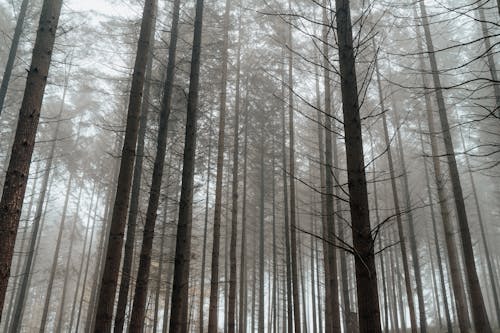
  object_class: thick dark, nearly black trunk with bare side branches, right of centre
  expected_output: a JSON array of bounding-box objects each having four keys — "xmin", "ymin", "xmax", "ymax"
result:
[{"xmin": 335, "ymin": 0, "xmax": 382, "ymax": 333}]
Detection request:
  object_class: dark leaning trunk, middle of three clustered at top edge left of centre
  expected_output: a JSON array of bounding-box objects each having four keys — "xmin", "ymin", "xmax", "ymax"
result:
[{"xmin": 130, "ymin": 0, "xmax": 180, "ymax": 326}]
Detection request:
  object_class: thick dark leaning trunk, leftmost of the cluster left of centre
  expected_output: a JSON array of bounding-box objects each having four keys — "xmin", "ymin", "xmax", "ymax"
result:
[{"xmin": 94, "ymin": 0, "xmax": 156, "ymax": 333}]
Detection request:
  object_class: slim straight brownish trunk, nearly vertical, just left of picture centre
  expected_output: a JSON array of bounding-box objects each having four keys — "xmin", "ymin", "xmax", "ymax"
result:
[{"xmin": 227, "ymin": 16, "xmax": 241, "ymax": 333}]
